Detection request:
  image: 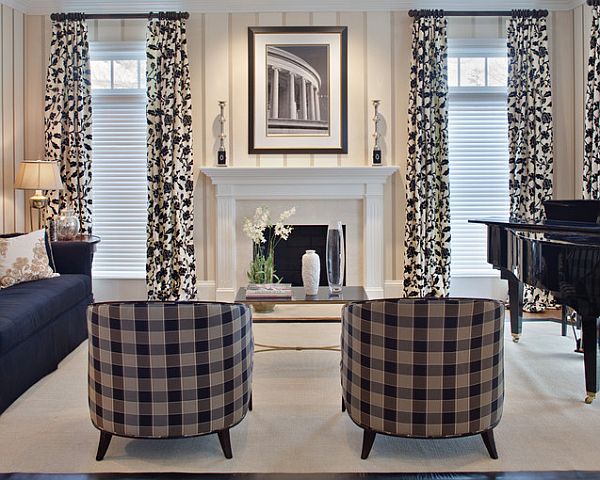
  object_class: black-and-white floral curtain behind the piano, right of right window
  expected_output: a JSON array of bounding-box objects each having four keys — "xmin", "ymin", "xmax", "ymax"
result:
[{"xmin": 508, "ymin": 11, "xmax": 555, "ymax": 312}]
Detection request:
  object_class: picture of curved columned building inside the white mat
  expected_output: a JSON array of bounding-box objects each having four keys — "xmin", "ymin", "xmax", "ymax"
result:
[{"xmin": 267, "ymin": 45, "xmax": 329, "ymax": 135}]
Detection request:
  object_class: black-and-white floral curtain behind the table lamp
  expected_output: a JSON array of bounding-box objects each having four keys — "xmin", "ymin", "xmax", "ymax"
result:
[{"xmin": 44, "ymin": 13, "xmax": 92, "ymax": 233}]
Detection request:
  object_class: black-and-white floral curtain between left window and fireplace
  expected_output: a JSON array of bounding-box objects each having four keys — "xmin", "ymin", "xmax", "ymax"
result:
[{"xmin": 146, "ymin": 13, "xmax": 197, "ymax": 300}]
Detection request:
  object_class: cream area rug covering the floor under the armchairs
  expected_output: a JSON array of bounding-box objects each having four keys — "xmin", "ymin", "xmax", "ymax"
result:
[{"xmin": 0, "ymin": 322, "xmax": 600, "ymax": 473}]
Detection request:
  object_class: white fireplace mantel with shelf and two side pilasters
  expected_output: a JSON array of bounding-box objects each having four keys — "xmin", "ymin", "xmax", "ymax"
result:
[{"xmin": 200, "ymin": 167, "xmax": 398, "ymax": 301}]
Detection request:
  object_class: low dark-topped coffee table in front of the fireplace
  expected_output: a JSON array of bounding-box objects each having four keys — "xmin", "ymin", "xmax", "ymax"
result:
[{"xmin": 235, "ymin": 287, "xmax": 369, "ymax": 352}]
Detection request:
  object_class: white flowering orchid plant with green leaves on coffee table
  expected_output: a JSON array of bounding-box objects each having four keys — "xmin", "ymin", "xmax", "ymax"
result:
[{"xmin": 243, "ymin": 206, "xmax": 296, "ymax": 283}]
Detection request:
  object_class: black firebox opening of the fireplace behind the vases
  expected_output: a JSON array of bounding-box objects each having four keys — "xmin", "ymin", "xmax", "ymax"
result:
[{"xmin": 266, "ymin": 225, "xmax": 346, "ymax": 287}]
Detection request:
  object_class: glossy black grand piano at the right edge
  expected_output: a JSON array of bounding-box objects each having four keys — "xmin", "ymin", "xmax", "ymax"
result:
[{"xmin": 470, "ymin": 200, "xmax": 600, "ymax": 404}]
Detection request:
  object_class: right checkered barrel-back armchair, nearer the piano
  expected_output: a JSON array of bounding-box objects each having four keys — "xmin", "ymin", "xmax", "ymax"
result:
[{"xmin": 341, "ymin": 299, "xmax": 504, "ymax": 459}]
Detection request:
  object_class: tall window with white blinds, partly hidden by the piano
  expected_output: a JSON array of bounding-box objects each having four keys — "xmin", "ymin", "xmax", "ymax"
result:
[{"xmin": 448, "ymin": 40, "xmax": 509, "ymax": 278}]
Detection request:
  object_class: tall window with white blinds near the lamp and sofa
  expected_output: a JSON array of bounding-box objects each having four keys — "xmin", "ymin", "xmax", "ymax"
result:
[{"xmin": 90, "ymin": 42, "xmax": 148, "ymax": 278}]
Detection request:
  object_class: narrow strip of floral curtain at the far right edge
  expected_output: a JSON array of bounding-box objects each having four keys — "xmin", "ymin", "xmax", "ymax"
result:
[{"xmin": 583, "ymin": 2, "xmax": 600, "ymax": 200}]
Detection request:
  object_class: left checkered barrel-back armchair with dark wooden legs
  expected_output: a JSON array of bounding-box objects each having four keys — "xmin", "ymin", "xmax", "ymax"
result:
[{"xmin": 88, "ymin": 302, "xmax": 254, "ymax": 460}]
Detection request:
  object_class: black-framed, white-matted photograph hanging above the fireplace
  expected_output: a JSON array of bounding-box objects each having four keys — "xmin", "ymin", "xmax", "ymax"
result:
[{"xmin": 248, "ymin": 27, "xmax": 348, "ymax": 154}]
